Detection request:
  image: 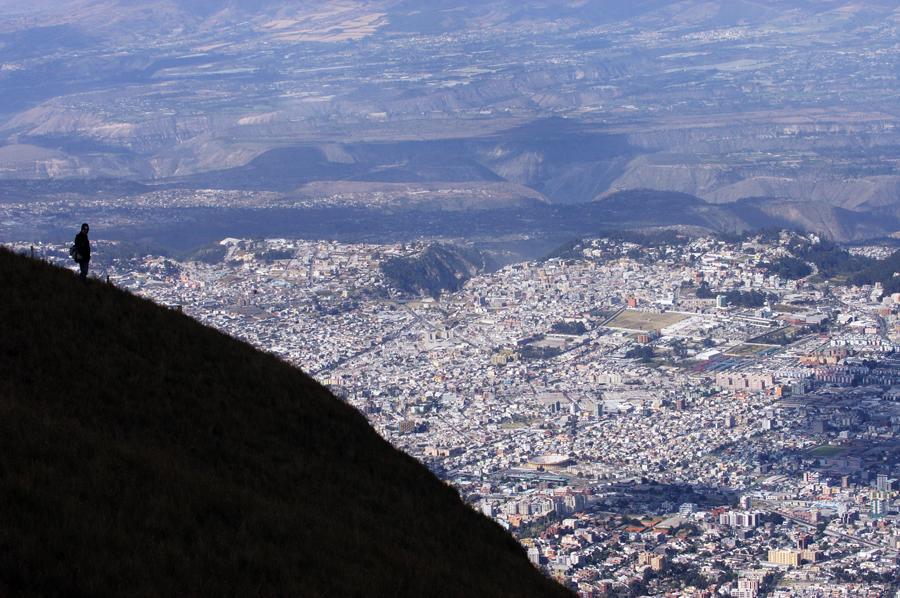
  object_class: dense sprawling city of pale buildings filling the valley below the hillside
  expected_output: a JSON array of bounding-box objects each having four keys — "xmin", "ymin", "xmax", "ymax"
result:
[{"xmin": 8, "ymin": 231, "xmax": 900, "ymax": 597}]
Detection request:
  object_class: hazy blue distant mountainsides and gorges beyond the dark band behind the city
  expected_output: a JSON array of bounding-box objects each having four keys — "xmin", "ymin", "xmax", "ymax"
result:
[{"xmin": 0, "ymin": 0, "xmax": 900, "ymax": 244}]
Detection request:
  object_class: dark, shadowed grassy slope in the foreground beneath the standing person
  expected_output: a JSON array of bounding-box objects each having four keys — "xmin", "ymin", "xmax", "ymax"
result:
[{"xmin": 0, "ymin": 250, "xmax": 568, "ymax": 597}]
